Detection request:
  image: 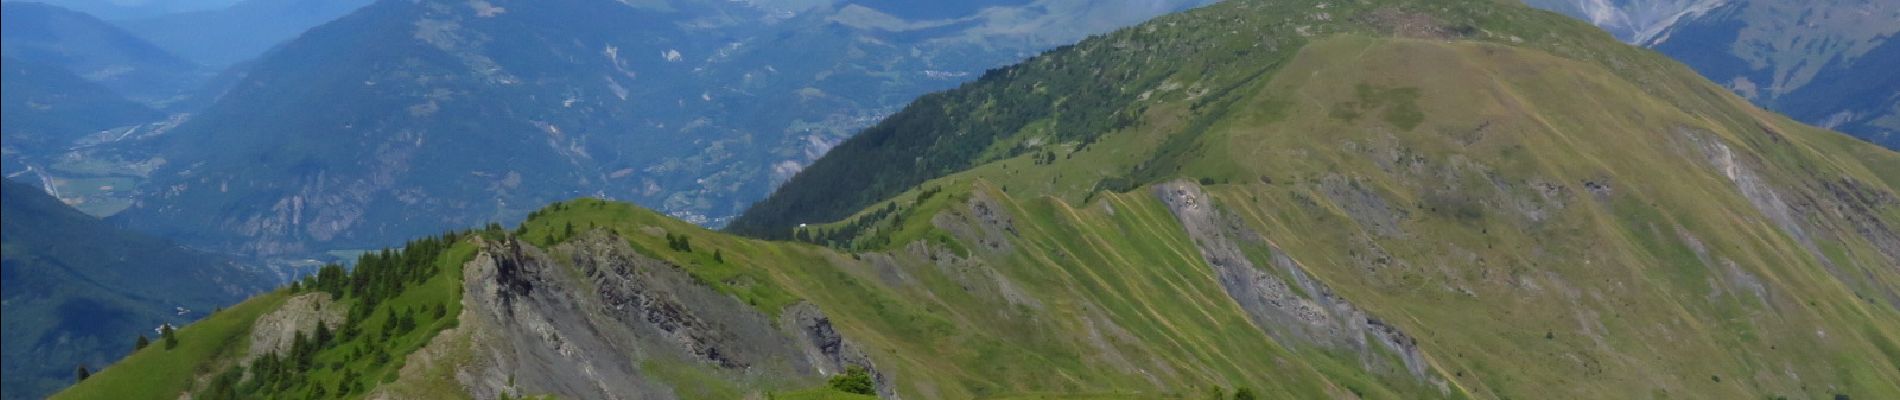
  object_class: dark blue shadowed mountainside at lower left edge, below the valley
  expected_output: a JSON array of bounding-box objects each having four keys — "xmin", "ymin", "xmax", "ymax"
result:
[{"xmin": 0, "ymin": 180, "xmax": 279, "ymax": 398}]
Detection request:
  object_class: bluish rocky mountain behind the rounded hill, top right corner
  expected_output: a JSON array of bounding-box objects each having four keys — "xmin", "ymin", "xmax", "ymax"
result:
[{"xmin": 1530, "ymin": 0, "xmax": 1900, "ymax": 148}]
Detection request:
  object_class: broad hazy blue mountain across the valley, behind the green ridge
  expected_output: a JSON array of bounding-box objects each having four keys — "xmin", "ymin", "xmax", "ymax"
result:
[{"xmin": 114, "ymin": 0, "xmax": 1203, "ymax": 254}]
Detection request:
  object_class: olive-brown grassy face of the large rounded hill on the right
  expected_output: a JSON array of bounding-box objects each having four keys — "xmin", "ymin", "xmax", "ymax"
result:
[{"xmin": 1207, "ymin": 40, "xmax": 1900, "ymax": 396}]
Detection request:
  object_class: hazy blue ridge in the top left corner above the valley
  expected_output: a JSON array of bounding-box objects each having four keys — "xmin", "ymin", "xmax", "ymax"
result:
[{"xmin": 0, "ymin": 2, "xmax": 205, "ymax": 106}]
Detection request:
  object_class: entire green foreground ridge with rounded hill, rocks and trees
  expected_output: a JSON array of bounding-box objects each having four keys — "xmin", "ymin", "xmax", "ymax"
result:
[{"xmin": 63, "ymin": 0, "xmax": 1900, "ymax": 398}]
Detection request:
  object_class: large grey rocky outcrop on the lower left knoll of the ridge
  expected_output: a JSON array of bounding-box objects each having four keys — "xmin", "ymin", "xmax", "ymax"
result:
[{"xmin": 456, "ymin": 231, "xmax": 870, "ymax": 398}]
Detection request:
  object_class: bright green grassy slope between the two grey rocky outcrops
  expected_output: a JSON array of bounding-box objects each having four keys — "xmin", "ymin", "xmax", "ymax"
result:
[{"xmin": 524, "ymin": 198, "xmax": 1438, "ymax": 398}]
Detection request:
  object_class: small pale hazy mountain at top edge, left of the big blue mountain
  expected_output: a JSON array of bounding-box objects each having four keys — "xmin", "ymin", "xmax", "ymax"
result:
[{"xmin": 118, "ymin": 0, "xmax": 372, "ymax": 66}]
